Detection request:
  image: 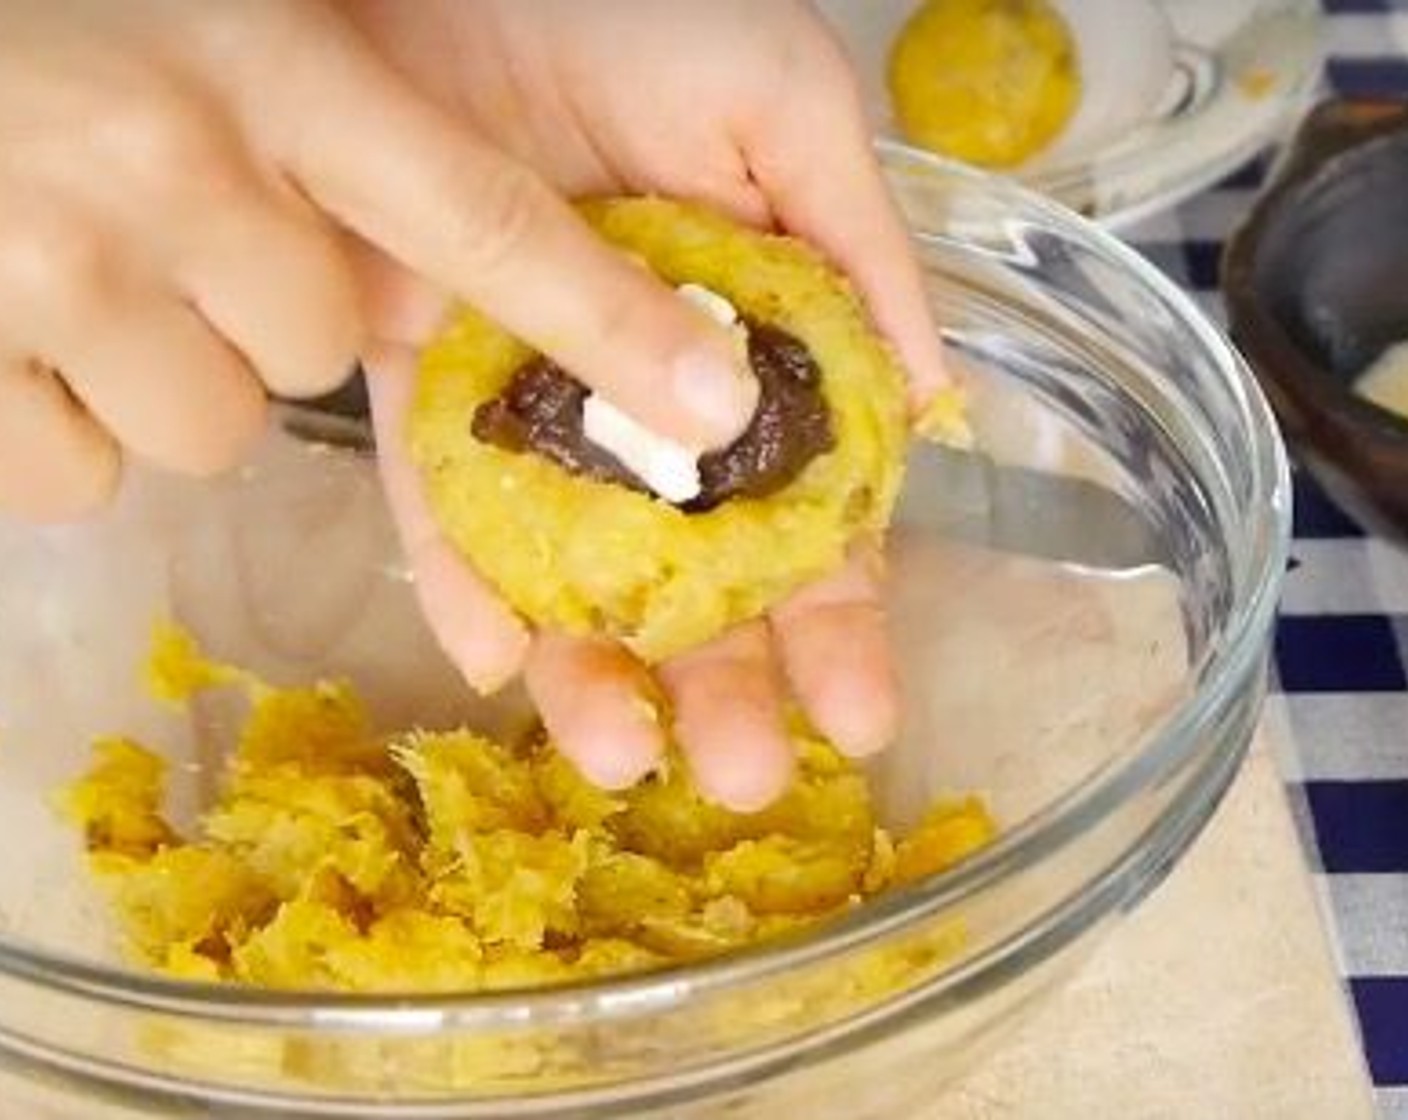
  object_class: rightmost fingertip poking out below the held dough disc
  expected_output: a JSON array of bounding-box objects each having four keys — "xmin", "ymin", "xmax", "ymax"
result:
[{"xmin": 770, "ymin": 549, "xmax": 900, "ymax": 757}]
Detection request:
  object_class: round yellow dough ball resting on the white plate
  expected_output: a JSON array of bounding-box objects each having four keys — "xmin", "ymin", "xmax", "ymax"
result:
[{"xmin": 888, "ymin": 0, "xmax": 1080, "ymax": 168}]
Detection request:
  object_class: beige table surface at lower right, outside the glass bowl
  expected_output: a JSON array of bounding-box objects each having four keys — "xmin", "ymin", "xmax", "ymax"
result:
[{"xmin": 914, "ymin": 735, "xmax": 1374, "ymax": 1120}]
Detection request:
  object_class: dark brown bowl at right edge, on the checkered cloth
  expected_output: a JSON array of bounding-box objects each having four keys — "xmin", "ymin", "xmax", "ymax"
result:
[{"xmin": 1222, "ymin": 100, "xmax": 1408, "ymax": 537}]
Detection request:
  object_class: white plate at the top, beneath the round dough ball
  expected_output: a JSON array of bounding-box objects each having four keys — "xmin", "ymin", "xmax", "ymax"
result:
[{"xmin": 819, "ymin": 0, "xmax": 1321, "ymax": 225}]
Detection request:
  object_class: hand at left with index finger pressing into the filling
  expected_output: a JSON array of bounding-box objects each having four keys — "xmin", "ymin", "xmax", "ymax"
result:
[{"xmin": 0, "ymin": 0, "xmax": 753, "ymax": 518}]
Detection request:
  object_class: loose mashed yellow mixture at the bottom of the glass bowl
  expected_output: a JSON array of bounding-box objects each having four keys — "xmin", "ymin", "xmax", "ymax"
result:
[{"xmin": 59, "ymin": 627, "xmax": 994, "ymax": 992}]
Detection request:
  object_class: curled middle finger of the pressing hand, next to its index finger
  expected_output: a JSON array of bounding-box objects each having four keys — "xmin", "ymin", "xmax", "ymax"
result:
[{"xmin": 173, "ymin": 192, "xmax": 363, "ymax": 397}]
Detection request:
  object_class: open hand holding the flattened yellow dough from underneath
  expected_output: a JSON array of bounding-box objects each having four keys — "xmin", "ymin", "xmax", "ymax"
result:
[{"xmin": 352, "ymin": 0, "xmax": 943, "ymax": 809}]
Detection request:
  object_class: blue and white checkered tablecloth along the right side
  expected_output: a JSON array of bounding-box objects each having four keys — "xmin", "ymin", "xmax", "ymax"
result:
[{"xmin": 1128, "ymin": 0, "xmax": 1408, "ymax": 1120}]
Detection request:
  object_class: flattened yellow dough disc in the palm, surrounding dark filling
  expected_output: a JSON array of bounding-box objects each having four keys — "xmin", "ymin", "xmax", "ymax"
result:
[{"xmin": 408, "ymin": 199, "xmax": 907, "ymax": 662}]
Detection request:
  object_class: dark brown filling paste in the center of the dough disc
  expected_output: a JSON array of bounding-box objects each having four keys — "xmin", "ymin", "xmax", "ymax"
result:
[{"xmin": 472, "ymin": 323, "xmax": 835, "ymax": 513}]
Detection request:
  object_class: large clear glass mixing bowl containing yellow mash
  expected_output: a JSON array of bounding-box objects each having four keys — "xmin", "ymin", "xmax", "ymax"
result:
[{"xmin": 0, "ymin": 149, "xmax": 1288, "ymax": 1120}]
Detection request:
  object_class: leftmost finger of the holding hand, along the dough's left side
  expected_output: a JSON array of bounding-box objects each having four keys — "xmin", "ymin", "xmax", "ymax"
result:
[{"xmin": 363, "ymin": 336, "xmax": 528, "ymax": 693}]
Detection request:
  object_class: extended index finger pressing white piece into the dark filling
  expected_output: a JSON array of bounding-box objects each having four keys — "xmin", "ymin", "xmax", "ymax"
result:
[{"xmin": 257, "ymin": 26, "xmax": 758, "ymax": 447}]
